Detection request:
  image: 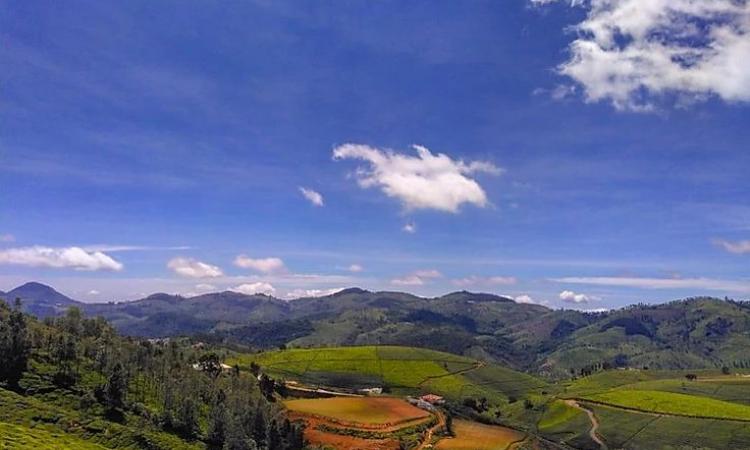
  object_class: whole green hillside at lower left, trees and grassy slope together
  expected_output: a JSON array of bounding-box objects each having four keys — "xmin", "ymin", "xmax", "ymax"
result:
[{"xmin": 0, "ymin": 302, "xmax": 304, "ymax": 450}]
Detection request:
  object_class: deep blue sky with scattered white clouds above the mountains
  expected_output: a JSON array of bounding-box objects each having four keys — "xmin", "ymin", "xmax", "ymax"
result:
[{"xmin": 0, "ymin": 0, "xmax": 750, "ymax": 309}]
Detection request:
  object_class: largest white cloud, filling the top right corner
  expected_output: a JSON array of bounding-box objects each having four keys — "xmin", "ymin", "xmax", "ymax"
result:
[{"xmin": 531, "ymin": 0, "xmax": 750, "ymax": 110}]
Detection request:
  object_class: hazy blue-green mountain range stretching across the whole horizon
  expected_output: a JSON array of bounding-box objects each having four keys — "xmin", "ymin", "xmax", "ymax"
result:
[{"xmin": 3, "ymin": 282, "xmax": 750, "ymax": 378}]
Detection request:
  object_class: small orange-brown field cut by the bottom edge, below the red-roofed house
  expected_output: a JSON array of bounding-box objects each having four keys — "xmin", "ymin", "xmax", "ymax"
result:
[{"xmin": 437, "ymin": 420, "xmax": 525, "ymax": 450}]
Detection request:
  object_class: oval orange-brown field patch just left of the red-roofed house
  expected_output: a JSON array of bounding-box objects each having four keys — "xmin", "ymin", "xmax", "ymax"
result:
[{"xmin": 284, "ymin": 397, "xmax": 429, "ymax": 425}]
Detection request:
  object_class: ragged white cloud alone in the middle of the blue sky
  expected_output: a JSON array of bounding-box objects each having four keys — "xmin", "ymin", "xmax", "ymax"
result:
[{"xmin": 333, "ymin": 144, "xmax": 502, "ymax": 213}]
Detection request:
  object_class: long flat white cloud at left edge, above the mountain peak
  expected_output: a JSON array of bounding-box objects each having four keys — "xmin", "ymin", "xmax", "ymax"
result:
[{"xmin": 0, "ymin": 245, "xmax": 123, "ymax": 271}]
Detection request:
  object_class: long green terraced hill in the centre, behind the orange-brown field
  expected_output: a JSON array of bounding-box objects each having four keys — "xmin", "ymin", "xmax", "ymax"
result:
[{"xmin": 228, "ymin": 346, "xmax": 548, "ymax": 402}]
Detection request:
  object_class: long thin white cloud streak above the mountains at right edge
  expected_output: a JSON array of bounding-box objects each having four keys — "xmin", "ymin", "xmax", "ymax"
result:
[{"xmin": 551, "ymin": 277, "xmax": 750, "ymax": 293}]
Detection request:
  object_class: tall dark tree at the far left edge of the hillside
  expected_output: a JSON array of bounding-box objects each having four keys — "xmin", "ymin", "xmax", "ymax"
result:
[{"xmin": 0, "ymin": 299, "xmax": 31, "ymax": 389}]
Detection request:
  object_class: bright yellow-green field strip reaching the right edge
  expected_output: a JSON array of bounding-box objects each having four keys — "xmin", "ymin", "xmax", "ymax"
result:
[{"xmin": 584, "ymin": 389, "xmax": 750, "ymax": 421}]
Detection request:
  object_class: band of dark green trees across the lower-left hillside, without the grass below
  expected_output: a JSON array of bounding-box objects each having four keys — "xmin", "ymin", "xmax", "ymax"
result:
[{"xmin": 0, "ymin": 301, "xmax": 304, "ymax": 450}]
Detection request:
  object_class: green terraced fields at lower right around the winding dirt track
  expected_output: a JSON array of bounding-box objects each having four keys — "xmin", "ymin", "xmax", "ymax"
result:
[{"xmin": 552, "ymin": 370, "xmax": 750, "ymax": 449}]
